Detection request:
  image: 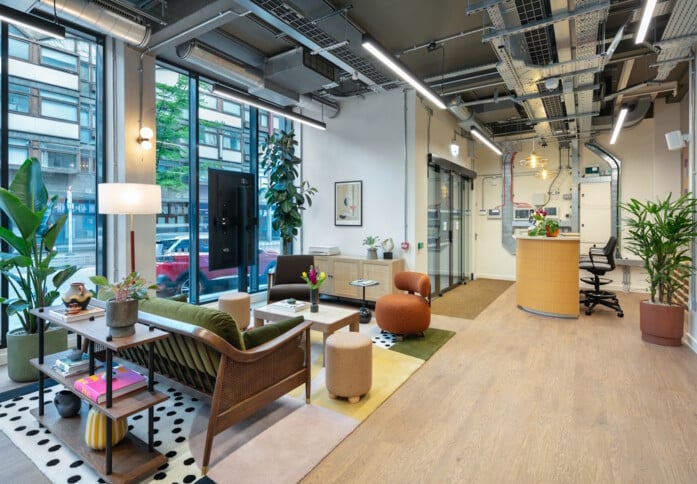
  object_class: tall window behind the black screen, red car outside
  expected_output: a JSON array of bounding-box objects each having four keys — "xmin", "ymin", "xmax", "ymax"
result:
[{"xmin": 156, "ymin": 65, "xmax": 290, "ymax": 302}]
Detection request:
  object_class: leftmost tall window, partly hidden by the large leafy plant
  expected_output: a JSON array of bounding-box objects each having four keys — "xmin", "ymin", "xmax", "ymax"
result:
[{"xmin": 1, "ymin": 25, "xmax": 103, "ymax": 345}]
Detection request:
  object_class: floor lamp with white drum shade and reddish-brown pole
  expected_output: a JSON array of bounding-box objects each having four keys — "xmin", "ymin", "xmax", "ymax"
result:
[{"xmin": 97, "ymin": 183, "xmax": 162, "ymax": 272}]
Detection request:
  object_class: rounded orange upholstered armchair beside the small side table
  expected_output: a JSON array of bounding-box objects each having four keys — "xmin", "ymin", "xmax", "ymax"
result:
[{"xmin": 375, "ymin": 272, "xmax": 431, "ymax": 335}]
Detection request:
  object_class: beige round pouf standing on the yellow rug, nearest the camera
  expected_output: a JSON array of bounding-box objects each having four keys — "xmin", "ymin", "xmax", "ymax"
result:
[{"xmin": 324, "ymin": 332, "xmax": 373, "ymax": 403}]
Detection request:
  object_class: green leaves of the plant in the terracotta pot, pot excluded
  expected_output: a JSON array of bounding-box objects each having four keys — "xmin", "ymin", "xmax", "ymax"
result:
[{"xmin": 622, "ymin": 194, "xmax": 697, "ymax": 304}]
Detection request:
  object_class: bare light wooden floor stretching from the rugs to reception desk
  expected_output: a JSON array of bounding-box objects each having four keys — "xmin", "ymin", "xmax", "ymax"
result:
[{"xmin": 303, "ymin": 286, "xmax": 697, "ymax": 484}]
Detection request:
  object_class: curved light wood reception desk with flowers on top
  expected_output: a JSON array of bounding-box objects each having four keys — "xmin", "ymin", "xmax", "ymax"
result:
[{"xmin": 516, "ymin": 235, "xmax": 580, "ymax": 318}]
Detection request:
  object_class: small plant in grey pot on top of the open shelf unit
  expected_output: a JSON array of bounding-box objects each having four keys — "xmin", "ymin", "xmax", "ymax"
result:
[{"xmin": 90, "ymin": 272, "xmax": 157, "ymax": 338}]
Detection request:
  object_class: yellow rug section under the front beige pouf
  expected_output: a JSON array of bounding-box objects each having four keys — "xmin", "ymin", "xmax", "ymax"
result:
[{"xmin": 289, "ymin": 331, "xmax": 424, "ymax": 421}]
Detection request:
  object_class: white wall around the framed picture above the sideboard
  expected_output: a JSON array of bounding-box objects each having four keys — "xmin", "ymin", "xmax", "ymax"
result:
[{"xmin": 300, "ymin": 90, "xmax": 464, "ymax": 272}]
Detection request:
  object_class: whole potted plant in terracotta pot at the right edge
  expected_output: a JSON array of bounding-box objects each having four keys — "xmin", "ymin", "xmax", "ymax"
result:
[{"xmin": 622, "ymin": 194, "xmax": 697, "ymax": 346}]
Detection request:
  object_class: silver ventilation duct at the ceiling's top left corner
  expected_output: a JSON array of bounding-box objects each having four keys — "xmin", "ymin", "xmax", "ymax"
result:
[{"xmin": 36, "ymin": 0, "xmax": 150, "ymax": 47}]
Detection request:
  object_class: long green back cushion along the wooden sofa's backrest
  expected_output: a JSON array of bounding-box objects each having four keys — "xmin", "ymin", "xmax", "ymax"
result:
[{"xmin": 140, "ymin": 297, "xmax": 245, "ymax": 351}]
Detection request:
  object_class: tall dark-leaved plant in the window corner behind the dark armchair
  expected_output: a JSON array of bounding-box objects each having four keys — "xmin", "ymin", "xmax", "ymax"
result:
[{"xmin": 261, "ymin": 131, "xmax": 317, "ymax": 255}]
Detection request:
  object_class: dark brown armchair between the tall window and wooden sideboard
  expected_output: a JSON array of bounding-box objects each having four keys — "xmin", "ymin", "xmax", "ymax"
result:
[{"xmin": 266, "ymin": 255, "xmax": 315, "ymax": 303}]
